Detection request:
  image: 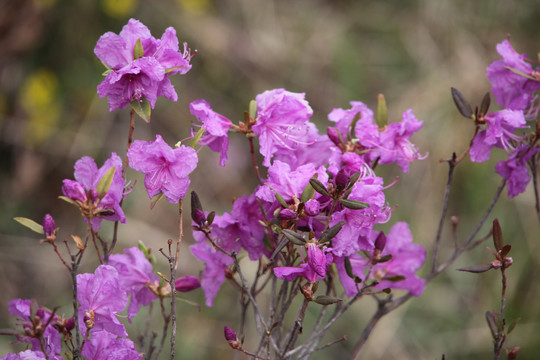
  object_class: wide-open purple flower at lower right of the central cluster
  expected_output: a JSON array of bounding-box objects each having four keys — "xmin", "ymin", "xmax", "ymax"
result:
[{"xmin": 336, "ymin": 222, "xmax": 426, "ymax": 297}]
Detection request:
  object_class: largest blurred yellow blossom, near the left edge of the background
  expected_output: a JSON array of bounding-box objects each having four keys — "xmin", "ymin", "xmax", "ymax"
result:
[{"xmin": 21, "ymin": 69, "xmax": 60, "ymax": 145}]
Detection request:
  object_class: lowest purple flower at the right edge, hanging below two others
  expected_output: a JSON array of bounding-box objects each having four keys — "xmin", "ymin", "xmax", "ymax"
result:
[{"xmin": 495, "ymin": 144, "xmax": 540, "ymax": 198}]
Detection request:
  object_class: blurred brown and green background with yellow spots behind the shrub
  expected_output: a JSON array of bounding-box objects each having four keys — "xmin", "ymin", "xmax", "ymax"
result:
[{"xmin": 0, "ymin": 0, "xmax": 540, "ymax": 359}]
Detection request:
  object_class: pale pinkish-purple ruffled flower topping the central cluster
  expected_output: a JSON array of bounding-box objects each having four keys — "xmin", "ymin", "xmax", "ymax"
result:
[{"xmin": 252, "ymin": 89, "xmax": 313, "ymax": 167}]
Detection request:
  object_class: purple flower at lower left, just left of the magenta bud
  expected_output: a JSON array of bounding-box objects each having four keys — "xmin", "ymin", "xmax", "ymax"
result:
[{"xmin": 109, "ymin": 247, "xmax": 159, "ymax": 321}]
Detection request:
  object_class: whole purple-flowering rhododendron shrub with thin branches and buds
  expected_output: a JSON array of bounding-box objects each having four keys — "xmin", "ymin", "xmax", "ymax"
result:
[{"xmin": 2, "ymin": 19, "xmax": 540, "ymax": 359}]
